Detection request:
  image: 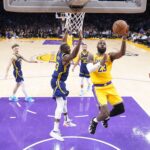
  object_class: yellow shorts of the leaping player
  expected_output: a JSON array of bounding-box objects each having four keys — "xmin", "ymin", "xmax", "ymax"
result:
[{"xmin": 93, "ymin": 84, "xmax": 123, "ymax": 106}]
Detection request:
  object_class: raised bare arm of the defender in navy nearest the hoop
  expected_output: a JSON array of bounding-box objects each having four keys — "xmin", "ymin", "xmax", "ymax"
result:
[{"xmin": 63, "ymin": 32, "xmax": 83, "ymax": 65}]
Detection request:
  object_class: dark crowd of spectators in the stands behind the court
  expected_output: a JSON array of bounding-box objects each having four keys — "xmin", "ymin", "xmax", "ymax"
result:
[{"xmin": 0, "ymin": 1, "xmax": 150, "ymax": 46}]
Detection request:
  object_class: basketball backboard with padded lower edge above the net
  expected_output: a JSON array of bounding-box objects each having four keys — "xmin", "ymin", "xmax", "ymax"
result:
[{"xmin": 3, "ymin": 0, "xmax": 147, "ymax": 13}]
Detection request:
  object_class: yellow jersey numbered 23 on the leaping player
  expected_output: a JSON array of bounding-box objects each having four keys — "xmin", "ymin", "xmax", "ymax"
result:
[{"xmin": 90, "ymin": 54, "xmax": 112, "ymax": 84}]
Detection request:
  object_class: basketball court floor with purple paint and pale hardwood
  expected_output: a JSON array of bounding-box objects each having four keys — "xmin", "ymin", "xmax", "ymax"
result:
[{"xmin": 0, "ymin": 39, "xmax": 150, "ymax": 150}]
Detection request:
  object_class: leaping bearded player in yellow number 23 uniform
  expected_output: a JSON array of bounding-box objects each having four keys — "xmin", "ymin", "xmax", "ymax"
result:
[{"xmin": 87, "ymin": 36, "xmax": 126, "ymax": 134}]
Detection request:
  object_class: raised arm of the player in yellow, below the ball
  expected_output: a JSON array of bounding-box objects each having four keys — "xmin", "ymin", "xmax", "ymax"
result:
[{"xmin": 109, "ymin": 36, "xmax": 127, "ymax": 61}]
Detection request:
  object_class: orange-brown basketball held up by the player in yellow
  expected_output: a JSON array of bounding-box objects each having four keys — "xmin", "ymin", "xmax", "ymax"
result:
[{"xmin": 112, "ymin": 20, "xmax": 128, "ymax": 35}]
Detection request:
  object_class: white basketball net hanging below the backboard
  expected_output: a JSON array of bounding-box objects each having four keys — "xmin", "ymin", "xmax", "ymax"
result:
[{"xmin": 65, "ymin": 12, "xmax": 85, "ymax": 33}]
